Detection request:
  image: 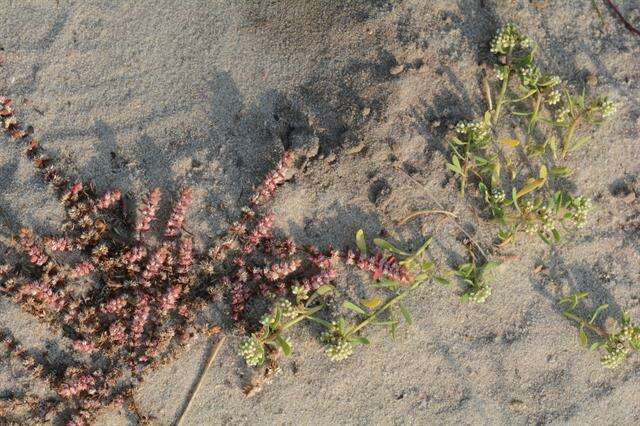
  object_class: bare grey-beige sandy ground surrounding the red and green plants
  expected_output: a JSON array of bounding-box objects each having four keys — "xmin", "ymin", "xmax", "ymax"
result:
[{"xmin": 0, "ymin": 0, "xmax": 640, "ymax": 425}]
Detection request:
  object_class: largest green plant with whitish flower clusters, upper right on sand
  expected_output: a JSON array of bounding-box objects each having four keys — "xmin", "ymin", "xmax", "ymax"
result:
[{"xmin": 447, "ymin": 24, "xmax": 615, "ymax": 245}]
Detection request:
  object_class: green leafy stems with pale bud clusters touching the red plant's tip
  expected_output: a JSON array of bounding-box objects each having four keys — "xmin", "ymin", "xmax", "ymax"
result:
[{"xmin": 239, "ymin": 230, "xmax": 442, "ymax": 366}]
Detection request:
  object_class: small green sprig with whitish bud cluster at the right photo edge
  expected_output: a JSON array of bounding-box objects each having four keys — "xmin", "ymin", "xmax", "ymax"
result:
[{"xmin": 559, "ymin": 292, "xmax": 640, "ymax": 368}]
